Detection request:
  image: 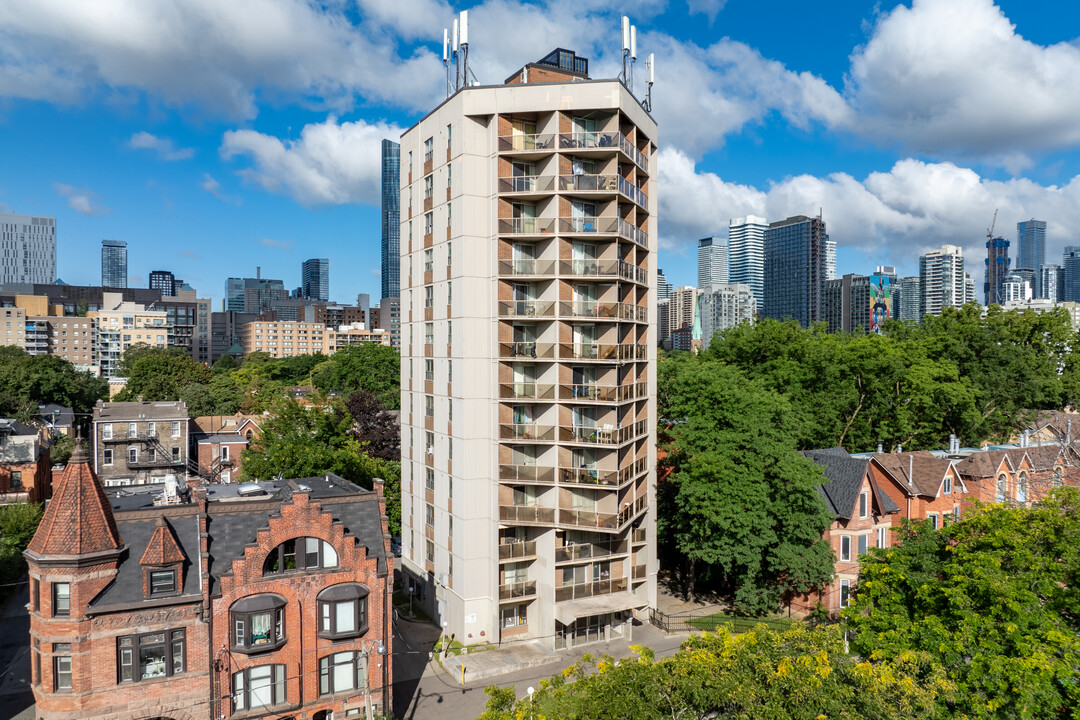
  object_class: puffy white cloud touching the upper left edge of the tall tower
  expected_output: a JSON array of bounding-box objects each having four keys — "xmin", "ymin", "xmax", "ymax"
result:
[{"xmin": 220, "ymin": 118, "xmax": 402, "ymax": 206}]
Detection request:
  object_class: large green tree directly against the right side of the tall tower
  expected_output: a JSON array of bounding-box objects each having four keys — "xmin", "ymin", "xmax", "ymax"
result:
[{"xmin": 658, "ymin": 357, "xmax": 835, "ymax": 614}]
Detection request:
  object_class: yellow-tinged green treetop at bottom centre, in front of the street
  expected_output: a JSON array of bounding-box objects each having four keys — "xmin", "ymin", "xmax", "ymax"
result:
[{"xmin": 481, "ymin": 627, "xmax": 951, "ymax": 720}]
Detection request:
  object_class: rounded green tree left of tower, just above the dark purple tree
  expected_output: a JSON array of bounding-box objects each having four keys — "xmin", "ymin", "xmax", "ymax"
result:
[{"xmin": 312, "ymin": 342, "xmax": 401, "ymax": 410}]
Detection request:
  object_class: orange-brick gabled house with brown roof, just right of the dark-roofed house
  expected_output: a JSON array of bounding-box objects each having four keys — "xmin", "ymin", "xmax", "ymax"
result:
[{"xmin": 869, "ymin": 450, "xmax": 968, "ymax": 528}]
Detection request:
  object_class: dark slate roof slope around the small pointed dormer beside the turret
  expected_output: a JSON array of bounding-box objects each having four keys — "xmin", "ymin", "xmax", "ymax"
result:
[{"xmin": 90, "ymin": 511, "xmax": 202, "ymax": 612}]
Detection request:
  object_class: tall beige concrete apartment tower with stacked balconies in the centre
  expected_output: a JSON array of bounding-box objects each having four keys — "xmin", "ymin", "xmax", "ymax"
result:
[{"xmin": 401, "ymin": 50, "xmax": 658, "ymax": 649}]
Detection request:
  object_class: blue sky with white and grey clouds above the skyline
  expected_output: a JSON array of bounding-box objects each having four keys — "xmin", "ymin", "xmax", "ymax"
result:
[{"xmin": 0, "ymin": 0, "xmax": 1080, "ymax": 303}]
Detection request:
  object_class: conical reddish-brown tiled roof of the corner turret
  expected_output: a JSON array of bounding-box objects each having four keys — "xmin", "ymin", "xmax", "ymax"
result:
[{"xmin": 26, "ymin": 444, "xmax": 123, "ymax": 558}]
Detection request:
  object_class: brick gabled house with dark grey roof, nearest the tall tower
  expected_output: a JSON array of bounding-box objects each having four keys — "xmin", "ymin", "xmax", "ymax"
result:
[{"xmin": 792, "ymin": 448, "xmax": 900, "ymax": 613}]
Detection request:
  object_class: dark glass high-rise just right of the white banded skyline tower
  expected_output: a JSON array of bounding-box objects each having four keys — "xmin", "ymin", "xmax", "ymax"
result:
[{"xmin": 764, "ymin": 215, "xmax": 836, "ymax": 327}]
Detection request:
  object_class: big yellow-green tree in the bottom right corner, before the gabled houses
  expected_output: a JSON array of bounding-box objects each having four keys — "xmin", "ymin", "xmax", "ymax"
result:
[{"xmin": 845, "ymin": 488, "xmax": 1080, "ymax": 719}]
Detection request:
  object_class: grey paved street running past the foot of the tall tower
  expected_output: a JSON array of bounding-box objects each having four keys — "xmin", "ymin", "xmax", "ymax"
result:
[{"xmin": 394, "ymin": 620, "xmax": 686, "ymax": 720}]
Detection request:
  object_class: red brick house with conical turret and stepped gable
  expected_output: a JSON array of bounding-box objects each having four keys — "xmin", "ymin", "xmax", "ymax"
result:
[{"xmin": 25, "ymin": 444, "xmax": 393, "ymax": 720}]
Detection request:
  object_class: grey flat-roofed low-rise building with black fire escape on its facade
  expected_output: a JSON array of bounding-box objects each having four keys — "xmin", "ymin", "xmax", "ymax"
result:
[{"xmin": 93, "ymin": 400, "xmax": 188, "ymax": 487}]
